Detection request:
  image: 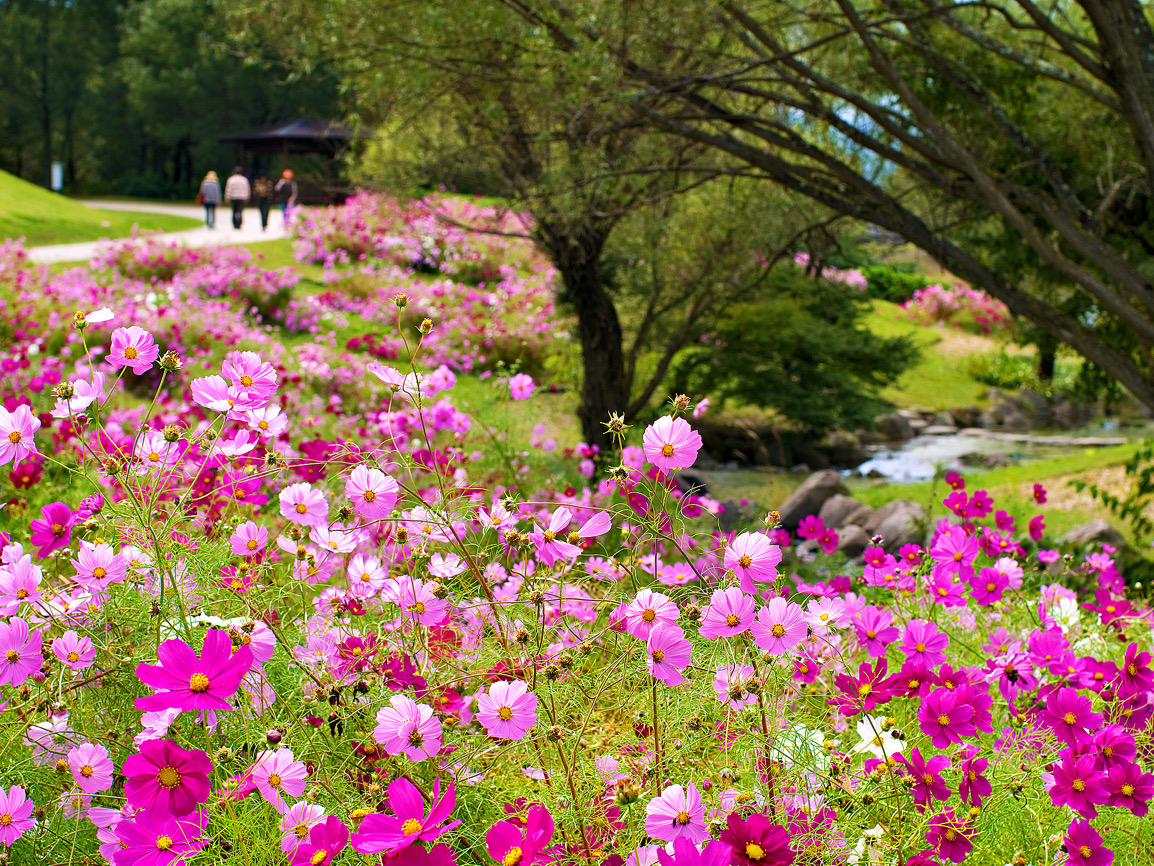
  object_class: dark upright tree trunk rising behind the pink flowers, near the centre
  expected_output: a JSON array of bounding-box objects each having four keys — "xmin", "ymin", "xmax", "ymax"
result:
[{"xmin": 540, "ymin": 224, "xmax": 629, "ymax": 454}]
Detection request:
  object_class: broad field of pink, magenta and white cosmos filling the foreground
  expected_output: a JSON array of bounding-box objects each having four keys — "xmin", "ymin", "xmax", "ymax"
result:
[{"xmin": 0, "ymin": 195, "xmax": 1154, "ymax": 866}]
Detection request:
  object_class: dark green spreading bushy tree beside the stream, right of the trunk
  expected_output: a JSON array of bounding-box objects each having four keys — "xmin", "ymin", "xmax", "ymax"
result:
[{"xmin": 672, "ymin": 264, "xmax": 917, "ymax": 433}]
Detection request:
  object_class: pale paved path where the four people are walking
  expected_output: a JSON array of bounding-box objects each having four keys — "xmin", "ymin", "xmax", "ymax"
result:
[{"xmin": 28, "ymin": 201, "xmax": 286, "ymax": 264}]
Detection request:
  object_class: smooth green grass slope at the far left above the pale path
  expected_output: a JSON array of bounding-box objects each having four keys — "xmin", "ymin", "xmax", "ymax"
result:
[{"xmin": 0, "ymin": 171, "xmax": 200, "ymax": 246}]
